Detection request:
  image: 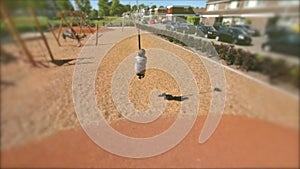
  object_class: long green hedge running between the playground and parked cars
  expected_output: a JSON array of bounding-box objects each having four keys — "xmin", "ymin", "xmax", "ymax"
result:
[{"xmin": 137, "ymin": 24, "xmax": 300, "ymax": 89}]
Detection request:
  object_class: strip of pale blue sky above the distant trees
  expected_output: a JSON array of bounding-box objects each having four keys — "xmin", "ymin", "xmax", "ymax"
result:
[{"xmin": 71, "ymin": 0, "xmax": 207, "ymax": 10}]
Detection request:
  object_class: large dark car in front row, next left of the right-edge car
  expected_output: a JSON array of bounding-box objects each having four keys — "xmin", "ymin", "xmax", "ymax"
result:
[{"xmin": 216, "ymin": 27, "xmax": 252, "ymax": 45}]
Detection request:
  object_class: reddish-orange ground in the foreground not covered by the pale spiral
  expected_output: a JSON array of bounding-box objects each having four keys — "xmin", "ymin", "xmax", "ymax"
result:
[{"xmin": 2, "ymin": 115, "xmax": 299, "ymax": 168}]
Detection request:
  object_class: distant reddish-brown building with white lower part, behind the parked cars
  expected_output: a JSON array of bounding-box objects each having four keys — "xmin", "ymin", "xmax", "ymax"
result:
[{"xmin": 166, "ymin": 5, "xmax": 195, "ymax": 22}]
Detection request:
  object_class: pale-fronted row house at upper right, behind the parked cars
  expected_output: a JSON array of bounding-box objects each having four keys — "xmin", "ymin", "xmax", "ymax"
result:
[{"xmin": 202, "ymin": 0, "xmax": 299, "ymax": 32}]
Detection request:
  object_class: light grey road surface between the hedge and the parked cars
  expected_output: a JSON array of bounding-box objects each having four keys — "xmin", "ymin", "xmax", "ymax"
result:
[{"xmin": 143, "ymin": 23, "xmax": 300, "ymax": 65}]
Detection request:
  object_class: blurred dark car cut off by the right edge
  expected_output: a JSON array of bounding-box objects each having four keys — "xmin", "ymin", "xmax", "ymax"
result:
[{"xmin": 261, "ymin": 33, "xmax": 300, "ymax": 57}]
